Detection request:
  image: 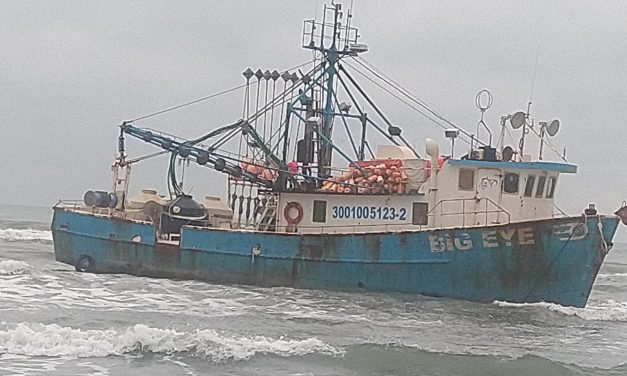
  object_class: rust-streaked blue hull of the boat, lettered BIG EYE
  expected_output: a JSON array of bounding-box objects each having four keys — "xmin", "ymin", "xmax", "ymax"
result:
[{"xmin": 52, "ymin": 209, "xmax": 619, "ymax": 307}]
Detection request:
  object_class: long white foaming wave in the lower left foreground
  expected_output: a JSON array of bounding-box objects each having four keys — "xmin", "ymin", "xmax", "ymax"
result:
[{"xmin": 0, "ymin": 323, "xmax": 344, "ymax": 362}]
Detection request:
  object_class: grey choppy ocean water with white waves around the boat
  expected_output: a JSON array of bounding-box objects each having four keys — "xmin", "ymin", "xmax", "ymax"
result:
[{"xmin": 0, "ymin": 206, "xmax": 627, "ymax": 376}]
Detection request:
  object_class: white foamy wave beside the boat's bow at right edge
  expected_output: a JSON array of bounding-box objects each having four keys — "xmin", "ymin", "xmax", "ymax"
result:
[{"xmin": 494, "ymin": 299, "xmax": 627, "ymax": 321}]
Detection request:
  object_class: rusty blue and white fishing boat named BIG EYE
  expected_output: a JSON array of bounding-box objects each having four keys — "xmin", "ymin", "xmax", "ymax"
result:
[{"xmin": 51, "ymin": 3, "xmax": 627, "ymax": 307}]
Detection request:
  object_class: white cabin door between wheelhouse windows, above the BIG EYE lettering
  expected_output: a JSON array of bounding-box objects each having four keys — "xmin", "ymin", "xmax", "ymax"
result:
[{"xmin": 474, "ymin": 168, "xmax": 503, "ymax": 225}]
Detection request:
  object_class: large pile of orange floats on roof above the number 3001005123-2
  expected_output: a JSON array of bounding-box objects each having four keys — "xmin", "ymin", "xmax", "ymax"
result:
[{"xmin": 320, "ymin": 159, "xmax": 408, "ymax": 194}]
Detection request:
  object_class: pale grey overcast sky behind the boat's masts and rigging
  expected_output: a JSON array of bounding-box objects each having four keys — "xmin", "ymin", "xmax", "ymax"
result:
[{"xmin": 0, "ymin": 0, "xmax": 627, "ymax": 238}]
